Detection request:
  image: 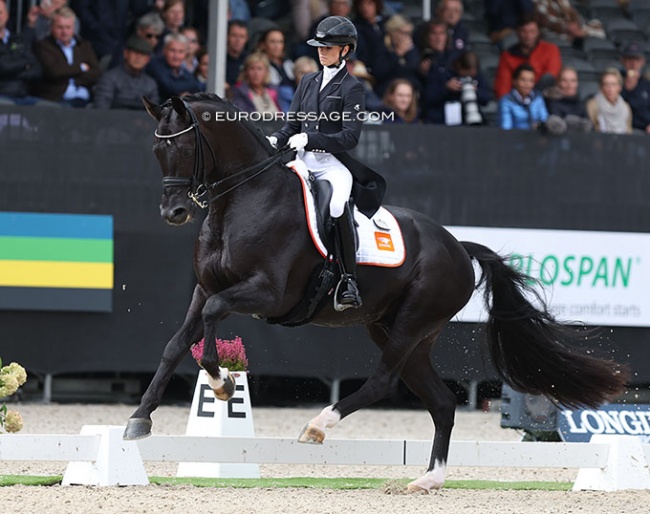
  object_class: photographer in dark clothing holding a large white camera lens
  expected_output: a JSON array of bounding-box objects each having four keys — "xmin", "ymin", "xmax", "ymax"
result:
[{"xmin": 423, "ymin": 52, "xmax": 492, "ymax": 125}]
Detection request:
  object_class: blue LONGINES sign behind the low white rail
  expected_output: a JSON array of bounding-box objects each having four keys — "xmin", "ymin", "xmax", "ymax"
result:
[{"xmin": 558, "ymin": 403, "xmax": 650, "ymax": 444}]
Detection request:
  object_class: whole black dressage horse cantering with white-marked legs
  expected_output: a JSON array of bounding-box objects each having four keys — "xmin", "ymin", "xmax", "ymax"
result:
[{"xmin": 124, "ymin": 94, "xmax": 628, "ymax": 491}]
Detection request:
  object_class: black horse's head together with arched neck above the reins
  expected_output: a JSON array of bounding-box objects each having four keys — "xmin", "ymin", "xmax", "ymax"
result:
[{"xmin": 143, "ymin": 94, "xmax": 274, "ymax": 225}]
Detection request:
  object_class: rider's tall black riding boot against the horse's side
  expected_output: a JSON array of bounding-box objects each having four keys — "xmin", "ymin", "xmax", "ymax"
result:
[{"xmin": 333, "ymin": 204, "xmax": 363, "ymax": 311}]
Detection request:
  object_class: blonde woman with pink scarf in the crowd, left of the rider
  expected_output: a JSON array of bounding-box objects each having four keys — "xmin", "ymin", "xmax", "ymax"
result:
[{"xmin": 231, "ymin": 52, "xmax": 281, "ymax": 113}]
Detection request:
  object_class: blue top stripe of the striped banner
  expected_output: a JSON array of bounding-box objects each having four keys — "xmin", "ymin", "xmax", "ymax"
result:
[{"xmin": 0, "ymin": 212, "xmax": 113, "ymax": 239}]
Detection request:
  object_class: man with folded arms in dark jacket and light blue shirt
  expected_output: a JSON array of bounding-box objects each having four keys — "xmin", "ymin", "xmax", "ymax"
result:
[{"xmin": 34, "ymin": 7, "xmax": 102, "ymax": 107}]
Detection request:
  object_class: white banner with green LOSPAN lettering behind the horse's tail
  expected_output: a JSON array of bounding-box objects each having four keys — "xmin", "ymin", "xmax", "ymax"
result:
[{"xmin": 446, "ymin": 227, "xmax": 650, "ymax": 327}]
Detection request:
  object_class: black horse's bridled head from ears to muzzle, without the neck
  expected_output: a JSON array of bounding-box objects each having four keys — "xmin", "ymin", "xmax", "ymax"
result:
[{"xmin": 142, "ymin": 97, "xmax": 205, "ymax": 225}]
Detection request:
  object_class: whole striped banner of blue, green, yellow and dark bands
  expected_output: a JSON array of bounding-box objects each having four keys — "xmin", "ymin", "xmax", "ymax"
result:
[{"xmin": 0, "ymin": 212, "xmax": 113, "ymax": 312}]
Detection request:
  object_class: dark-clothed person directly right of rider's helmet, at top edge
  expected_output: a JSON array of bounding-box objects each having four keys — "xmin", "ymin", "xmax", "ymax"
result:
[{"xmin": 352, "ymin": 0, "xmax": 387, "ymax": 77}]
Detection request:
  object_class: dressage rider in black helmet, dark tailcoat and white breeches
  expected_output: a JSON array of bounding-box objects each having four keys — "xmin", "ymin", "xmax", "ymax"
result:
[{"xmin": 269, "ymin": 16, "xmax": 386, "ymax": 311}]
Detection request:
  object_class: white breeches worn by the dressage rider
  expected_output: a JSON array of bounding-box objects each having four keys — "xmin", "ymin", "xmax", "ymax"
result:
[{"xmin": 297, "ymin": 151, "xmax": 352, "ymax": 218}]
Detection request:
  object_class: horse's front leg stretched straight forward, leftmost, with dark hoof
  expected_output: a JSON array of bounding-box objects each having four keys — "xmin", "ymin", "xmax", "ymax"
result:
[{"xmin": 123, "ymin": 286, "xmax": 205, "ymax": 440}]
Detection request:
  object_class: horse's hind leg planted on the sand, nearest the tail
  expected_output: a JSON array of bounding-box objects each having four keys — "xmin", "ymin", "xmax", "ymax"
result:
[{"xmin": 400, "ymin": 337, "xmax": 456, "ymax": 491}]
